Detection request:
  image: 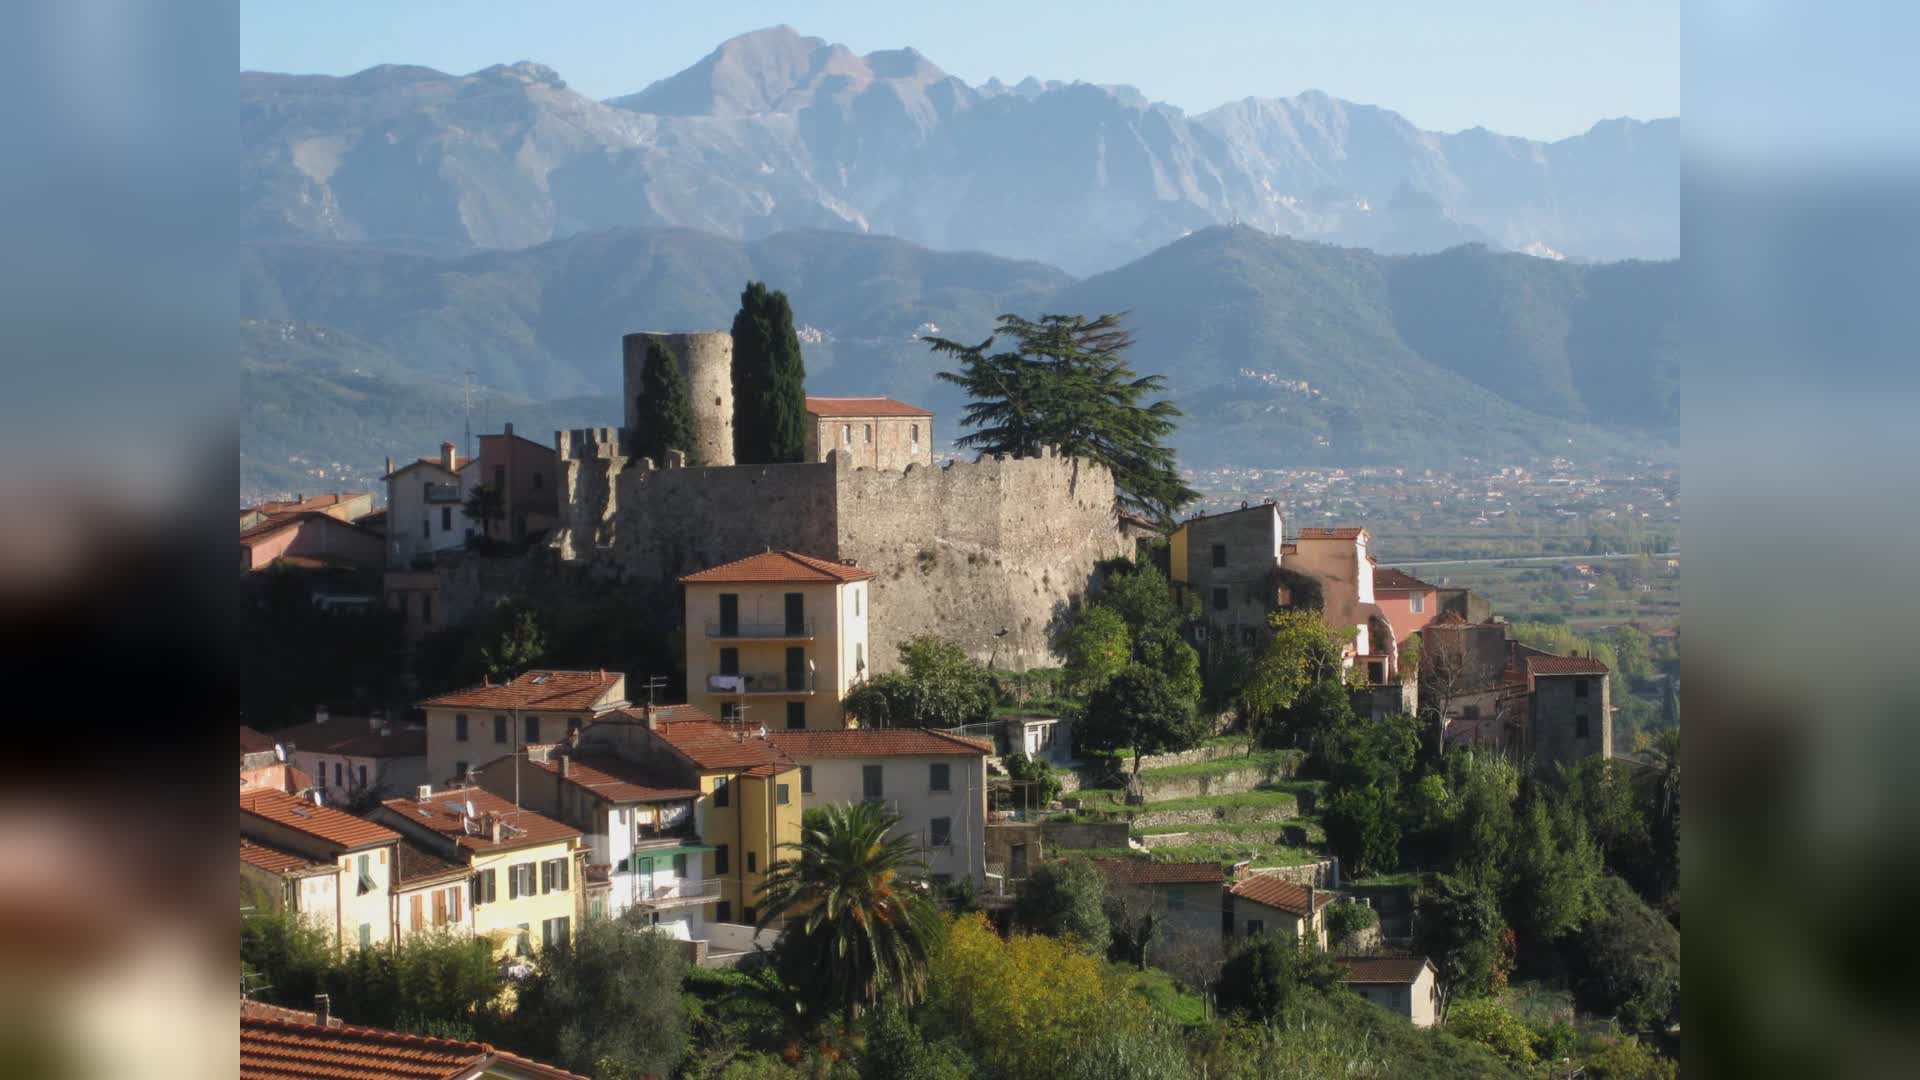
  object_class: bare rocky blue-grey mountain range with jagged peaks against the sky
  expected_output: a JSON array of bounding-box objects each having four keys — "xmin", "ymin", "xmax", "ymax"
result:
[{"xmin": 240, "ymin": 27, "xmax": 1680, "ymax": 275}]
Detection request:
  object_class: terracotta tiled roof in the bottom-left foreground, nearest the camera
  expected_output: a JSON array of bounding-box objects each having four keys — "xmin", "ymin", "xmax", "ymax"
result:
[{"xmin": 240, "ymin": 1015, "xmax": 584, "ymax": 1080}]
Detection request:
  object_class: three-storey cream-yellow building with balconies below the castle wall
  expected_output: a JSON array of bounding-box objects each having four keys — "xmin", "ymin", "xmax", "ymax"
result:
[{"xmin": 680, "ymin": 552, "xmax": 874, "ymax": 730}]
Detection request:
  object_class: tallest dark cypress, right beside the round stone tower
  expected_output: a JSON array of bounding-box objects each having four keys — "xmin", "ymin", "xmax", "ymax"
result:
[{"xmin": 733, "ymin": 281, "xmax": 806, "ymax": 465}]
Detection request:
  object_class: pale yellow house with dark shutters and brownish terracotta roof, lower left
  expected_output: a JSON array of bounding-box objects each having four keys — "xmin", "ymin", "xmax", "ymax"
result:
[{"xmin": 374, "ymin": 786, "xmax": 586, "ymax": 955}]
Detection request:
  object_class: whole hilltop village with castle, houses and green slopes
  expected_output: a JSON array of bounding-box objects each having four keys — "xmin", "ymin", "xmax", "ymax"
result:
[{"xmin": 238, "ymin": 294, "xmax": 1678, "ymax": 1076}]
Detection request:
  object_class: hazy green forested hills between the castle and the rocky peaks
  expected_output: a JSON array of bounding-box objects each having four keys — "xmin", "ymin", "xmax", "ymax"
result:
[{"xmin": 240, "ymin": 226, "xmax": 1680, "ymax": 490}]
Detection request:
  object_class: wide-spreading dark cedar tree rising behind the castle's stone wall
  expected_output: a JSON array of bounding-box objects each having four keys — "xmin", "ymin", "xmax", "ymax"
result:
[{"xmin": 925, "ymin": 311, "xmax": 1196, "ymax": 523}]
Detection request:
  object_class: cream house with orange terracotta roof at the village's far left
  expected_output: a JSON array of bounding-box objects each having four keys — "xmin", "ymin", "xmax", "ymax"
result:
[{"xmin": 240, "ymin": 776, "xmax": 399, "ymax": 947}]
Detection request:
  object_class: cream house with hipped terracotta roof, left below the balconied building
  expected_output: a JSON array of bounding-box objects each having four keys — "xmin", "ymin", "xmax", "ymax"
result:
[{"xmin": 420, "ymin": 671, "xmax": 628, "ymax": 784}]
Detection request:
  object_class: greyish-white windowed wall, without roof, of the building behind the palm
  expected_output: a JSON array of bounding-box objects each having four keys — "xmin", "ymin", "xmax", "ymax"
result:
[{"xmin": 793, "ymin": 753, "xmax": 987, "ymax": 886}]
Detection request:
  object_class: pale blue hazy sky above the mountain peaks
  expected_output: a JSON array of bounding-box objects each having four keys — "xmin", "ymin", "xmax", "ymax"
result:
[{"xmin": 240, "ymin": 0, "xmax": 1680, "ymax": 138}]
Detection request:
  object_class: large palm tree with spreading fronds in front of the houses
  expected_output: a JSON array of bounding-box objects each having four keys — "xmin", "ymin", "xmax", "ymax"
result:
[{"xmin": 760, "ymin": 803, "xmax": 939, "ymax": 1022}]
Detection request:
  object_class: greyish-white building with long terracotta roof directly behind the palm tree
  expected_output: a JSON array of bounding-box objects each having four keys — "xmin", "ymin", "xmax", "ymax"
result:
[{"xmin": 768, "ymin": 728, "xmax": 993, "ymax": 886}]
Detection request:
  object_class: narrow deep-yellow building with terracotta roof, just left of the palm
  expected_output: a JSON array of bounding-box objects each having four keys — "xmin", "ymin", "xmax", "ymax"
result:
[{"xmin": 649, "ymin": 709, "xmax": 801, "ymax": 924}]
